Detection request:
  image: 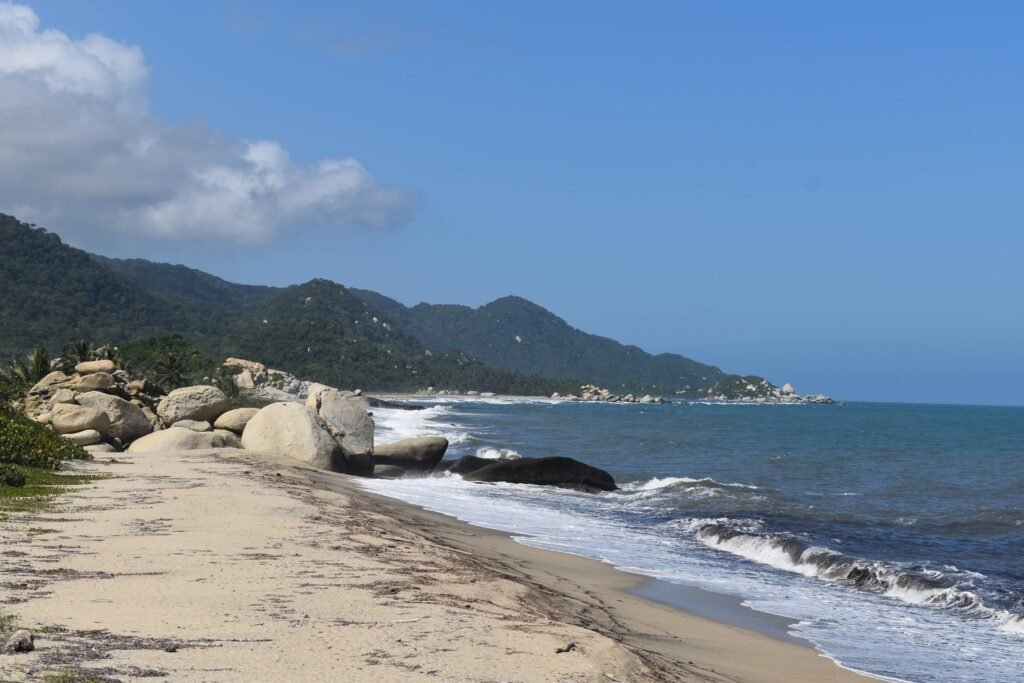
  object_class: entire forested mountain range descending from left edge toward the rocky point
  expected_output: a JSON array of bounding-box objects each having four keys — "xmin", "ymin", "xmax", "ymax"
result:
[{"xmin": 0, "ymin": 214, "xmax": 737, "ymax": 394}]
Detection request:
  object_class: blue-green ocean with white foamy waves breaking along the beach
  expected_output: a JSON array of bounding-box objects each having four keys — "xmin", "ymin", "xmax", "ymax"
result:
[{"xmin": 364, "ymin": 399, "xmax": 1024, "ymax": 683}]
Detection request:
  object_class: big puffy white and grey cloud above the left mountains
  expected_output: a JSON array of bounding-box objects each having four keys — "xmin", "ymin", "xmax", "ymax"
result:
[{"xmin": 0, "ymin": 2, "xmax": 412, "ymax": 242}]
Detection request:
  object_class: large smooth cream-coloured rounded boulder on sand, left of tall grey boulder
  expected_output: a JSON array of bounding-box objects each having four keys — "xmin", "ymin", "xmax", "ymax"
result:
[{"xmin": 241, "ymin": 402, "xmax": 346, "ymax": 472}]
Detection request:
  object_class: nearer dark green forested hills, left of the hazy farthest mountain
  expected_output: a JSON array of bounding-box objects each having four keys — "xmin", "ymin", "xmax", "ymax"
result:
[{"xmin": 0, "ymin": 214, "xmax": 571, "ymax": 394}]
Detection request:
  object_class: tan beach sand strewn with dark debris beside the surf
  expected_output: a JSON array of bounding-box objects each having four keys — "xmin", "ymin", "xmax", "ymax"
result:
[{"xmin": 0, "ymin": 450, "xmax": 865, "ymax": 683}]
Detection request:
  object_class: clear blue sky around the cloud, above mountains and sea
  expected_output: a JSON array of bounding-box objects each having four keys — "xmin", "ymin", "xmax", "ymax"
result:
[{"xmin": 8, "ymin": 1, "xmax": 1024, "ymax": 404}]
